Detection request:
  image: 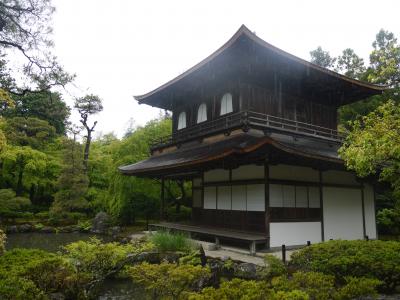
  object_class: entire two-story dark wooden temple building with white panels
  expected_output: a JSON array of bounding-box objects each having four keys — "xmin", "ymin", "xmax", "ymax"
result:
[{"xmin": 120, "ymin": 26, "xmax": 384, "ymax": 251}]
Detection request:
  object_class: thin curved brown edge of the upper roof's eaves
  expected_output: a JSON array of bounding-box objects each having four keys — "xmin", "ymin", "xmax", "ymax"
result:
[{"xmin": 134, "ymin": 25, "xmax": 388, "ymax": 104}]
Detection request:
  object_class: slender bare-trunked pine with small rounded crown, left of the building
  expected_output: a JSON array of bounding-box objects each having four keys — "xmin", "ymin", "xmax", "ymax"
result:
[{"xmin": 75, "ymin": 94, "xmax": 103, "ymax": 170}]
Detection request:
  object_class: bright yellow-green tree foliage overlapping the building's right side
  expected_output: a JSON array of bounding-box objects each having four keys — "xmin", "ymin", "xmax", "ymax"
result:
[{"xmin": 339, "ymin": 101, "xmax": 400, "ymax": 197}]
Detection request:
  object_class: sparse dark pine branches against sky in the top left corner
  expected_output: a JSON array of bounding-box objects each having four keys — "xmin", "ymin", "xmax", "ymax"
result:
[{"xmin": 0, "ymin": 0, "xmax": 74, "ymax": 94}]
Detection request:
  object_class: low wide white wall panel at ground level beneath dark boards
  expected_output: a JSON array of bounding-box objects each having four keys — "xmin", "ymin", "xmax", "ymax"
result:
[{"xmin": 269, "ymin": 222, "xmax": 321, "ymax": 247}]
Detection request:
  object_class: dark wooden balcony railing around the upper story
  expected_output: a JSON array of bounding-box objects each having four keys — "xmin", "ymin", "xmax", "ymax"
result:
[{"xmin": 151, "ymin": 111, "xmax": 343, "ymax": 151}]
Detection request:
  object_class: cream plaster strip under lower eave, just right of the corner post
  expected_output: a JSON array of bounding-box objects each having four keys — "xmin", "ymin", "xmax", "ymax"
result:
[{"xmin": 269, "ymin": 165, "xmax": 319, "ymax": 182}]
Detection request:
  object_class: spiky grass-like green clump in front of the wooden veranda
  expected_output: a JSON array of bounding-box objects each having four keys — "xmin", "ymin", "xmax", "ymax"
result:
[{"xmin": 150, "ymin": 231, "xmax": 194, "ymax": 252}]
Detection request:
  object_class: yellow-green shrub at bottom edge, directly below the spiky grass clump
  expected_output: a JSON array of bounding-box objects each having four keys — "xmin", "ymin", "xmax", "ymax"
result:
[{"xmin": 128, "ymin": 262, "xmax": 210, "ymax": 299}]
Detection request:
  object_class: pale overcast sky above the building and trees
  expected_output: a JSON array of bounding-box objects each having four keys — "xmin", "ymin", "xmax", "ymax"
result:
[{"xmin": 53, "ymin": 0, "xmax": 400, "ymax": 136}]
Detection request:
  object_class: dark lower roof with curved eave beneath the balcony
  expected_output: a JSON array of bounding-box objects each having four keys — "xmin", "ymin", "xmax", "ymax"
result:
[{"xmin": 118, "ymin": 132, "xmax": 343, "ymax": 178}]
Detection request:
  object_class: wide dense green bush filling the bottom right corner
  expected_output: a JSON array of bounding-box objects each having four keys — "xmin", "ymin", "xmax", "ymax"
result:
[{"xmin": 290, "ymin": 241, "xmax": 400, "ymax": 292}]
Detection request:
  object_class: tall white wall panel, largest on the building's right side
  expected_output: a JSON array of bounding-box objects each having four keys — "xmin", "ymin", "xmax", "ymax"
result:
[{"xmin": 322, "ymin": 187, "xmax": 363, "ymax": 240}]
